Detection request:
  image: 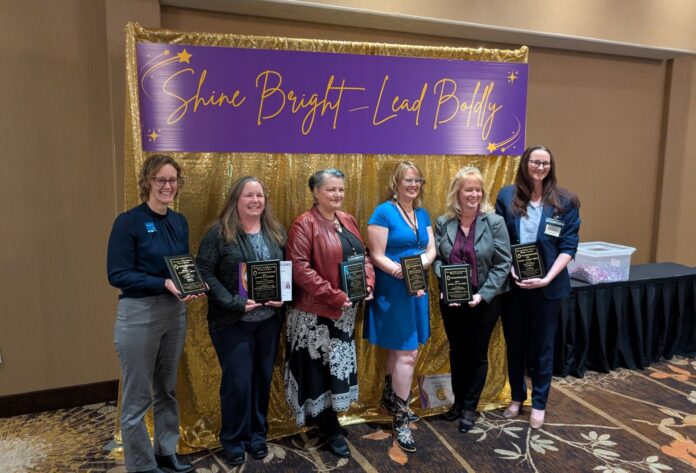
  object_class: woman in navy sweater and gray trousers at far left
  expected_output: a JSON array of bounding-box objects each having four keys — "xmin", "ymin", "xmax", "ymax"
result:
[{"xmin": 107, "ymin": 155, "xmax": 199, "ymax": 473}]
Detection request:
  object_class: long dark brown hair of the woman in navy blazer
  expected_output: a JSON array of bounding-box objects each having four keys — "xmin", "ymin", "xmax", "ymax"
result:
[{"xmin": 512, "ymin": 145, "xmax": 580, "ymax": 216}]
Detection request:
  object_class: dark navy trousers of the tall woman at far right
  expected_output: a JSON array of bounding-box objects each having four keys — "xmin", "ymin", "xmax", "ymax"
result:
[{"xmin": 502, "ymin": 287, "xmax": 561, "ymax": 410}]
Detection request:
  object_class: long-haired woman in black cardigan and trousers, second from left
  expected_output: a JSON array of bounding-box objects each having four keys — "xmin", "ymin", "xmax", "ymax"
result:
[{"xmin": 197, "ymin": 176, "xmax": 286, "ymax": 465}]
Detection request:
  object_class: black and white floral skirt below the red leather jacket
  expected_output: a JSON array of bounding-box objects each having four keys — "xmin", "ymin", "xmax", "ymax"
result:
[{"xmin": 285, "ymin": 307, "xmax": 358, "ymax": 426}]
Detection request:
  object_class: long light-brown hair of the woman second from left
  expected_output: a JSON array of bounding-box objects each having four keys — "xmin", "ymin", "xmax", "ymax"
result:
[{"xmin": 218, "ymin": 176, "xmax": 286, "ymax": 246}]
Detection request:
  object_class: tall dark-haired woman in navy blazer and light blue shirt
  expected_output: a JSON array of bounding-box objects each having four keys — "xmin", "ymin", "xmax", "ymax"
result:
[{"xmin": 495, "ymin": 145, "xmax": 580, "ymax": 429}]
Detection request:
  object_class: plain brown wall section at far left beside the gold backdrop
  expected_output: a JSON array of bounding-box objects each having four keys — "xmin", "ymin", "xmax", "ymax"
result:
[{"xmin": 0, "ymin": 0, "xmax": 159, "ymax": 396}]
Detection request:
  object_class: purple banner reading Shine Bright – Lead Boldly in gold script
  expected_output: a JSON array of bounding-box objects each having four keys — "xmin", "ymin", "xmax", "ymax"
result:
[{"xmin": 137, "ymin": 43, "xmax": 527, "ymax": 154}]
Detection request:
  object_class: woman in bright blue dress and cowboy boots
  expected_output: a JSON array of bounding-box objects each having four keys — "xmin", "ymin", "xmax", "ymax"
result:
[{"xmin": 364, "ymin": 161, "xmax": 436, "ymax": 452}]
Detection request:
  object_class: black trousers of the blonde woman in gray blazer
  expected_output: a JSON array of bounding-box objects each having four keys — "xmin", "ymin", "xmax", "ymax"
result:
[{"xmin": 440, "ymin": 298, "xmax": 499, "ymax": 411}]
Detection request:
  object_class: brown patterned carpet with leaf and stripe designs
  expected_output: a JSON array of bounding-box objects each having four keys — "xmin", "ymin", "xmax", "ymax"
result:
[{"xmin": 0, "ymin": 358, "xmax": 696, "ymax": 473}]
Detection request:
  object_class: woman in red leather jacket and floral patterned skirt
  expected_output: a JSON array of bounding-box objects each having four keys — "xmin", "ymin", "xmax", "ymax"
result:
[{"xmin": 285, "ymin": 169, "xmax": 374, "ymax": 457}]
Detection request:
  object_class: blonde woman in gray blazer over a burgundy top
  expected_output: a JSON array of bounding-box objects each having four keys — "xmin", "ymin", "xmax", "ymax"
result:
[{"xmin": 433, "ymin": 166, "xmax": 512, "ymax": 432}]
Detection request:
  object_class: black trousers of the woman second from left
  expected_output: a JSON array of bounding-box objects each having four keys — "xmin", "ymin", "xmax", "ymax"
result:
[{"xmin": 210, "ymin": 316, "xmax": 281, "ymax": 454}]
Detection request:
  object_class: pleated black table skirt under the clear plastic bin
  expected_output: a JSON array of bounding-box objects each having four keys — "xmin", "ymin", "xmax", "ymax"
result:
[{"xmin": 554, "ymin": 263, "xmax": 696, "ymax": 377}]
